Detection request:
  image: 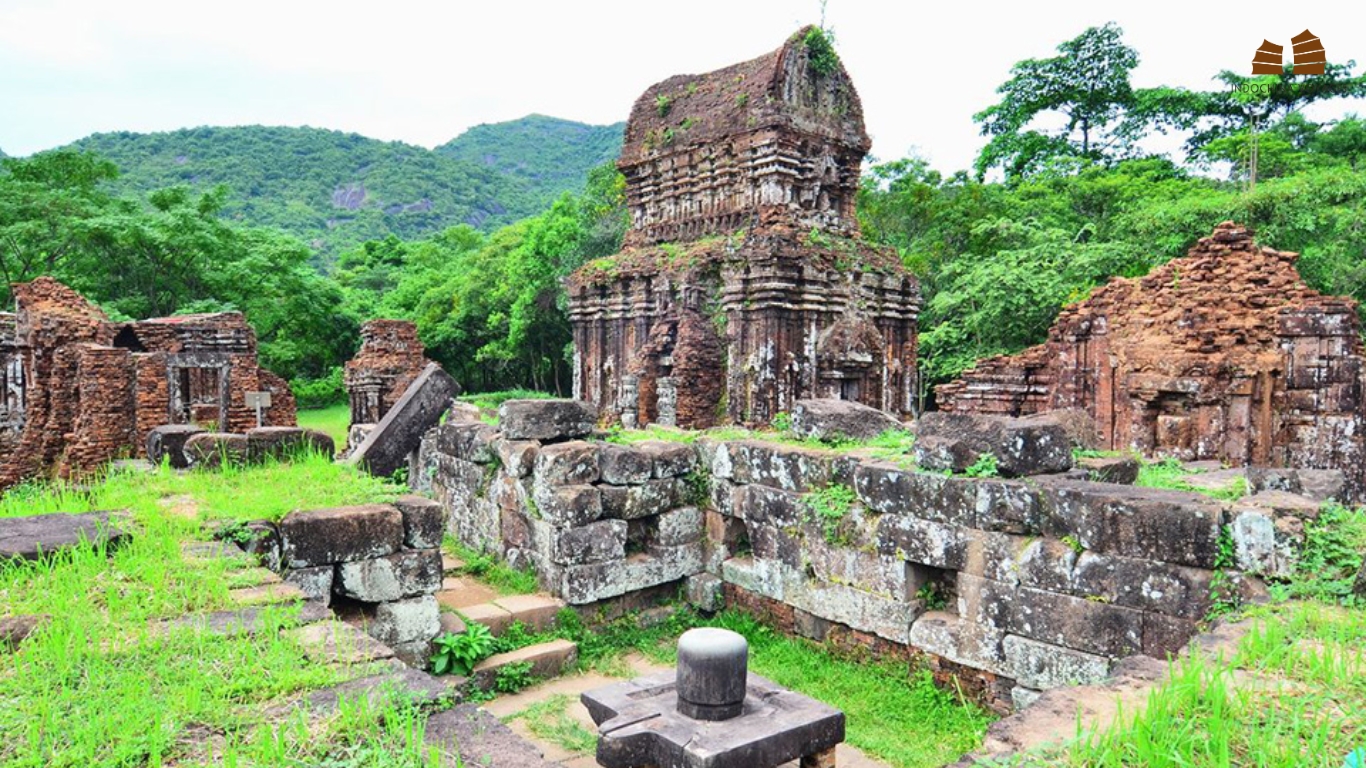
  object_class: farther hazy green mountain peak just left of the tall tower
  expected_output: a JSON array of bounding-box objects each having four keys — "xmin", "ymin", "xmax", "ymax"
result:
[{"xmin": 436, "ymin": 115, "xmax": 626, "ymax": 206}]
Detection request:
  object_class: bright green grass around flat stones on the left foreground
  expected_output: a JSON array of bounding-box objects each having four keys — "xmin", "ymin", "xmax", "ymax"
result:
[{"xmin": 0, "ymin": 462, "xmax": 433, "ymax": 768}]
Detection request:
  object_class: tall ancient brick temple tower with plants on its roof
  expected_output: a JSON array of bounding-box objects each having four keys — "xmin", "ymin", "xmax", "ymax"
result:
[{"xmin": 568, "ymin": 27, "xmax": 919, "ymax": 428}]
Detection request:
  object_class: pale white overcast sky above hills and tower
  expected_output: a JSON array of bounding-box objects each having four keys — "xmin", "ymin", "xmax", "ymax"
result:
[{"xmin": 0, "ymin": 0, "xmax": 1366, "ymax": 171}]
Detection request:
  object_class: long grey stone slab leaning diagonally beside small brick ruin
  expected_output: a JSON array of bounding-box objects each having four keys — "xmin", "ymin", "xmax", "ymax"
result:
[{"xmin": 347, "ymin": 362, "xmax": 460, "ymax": 477}]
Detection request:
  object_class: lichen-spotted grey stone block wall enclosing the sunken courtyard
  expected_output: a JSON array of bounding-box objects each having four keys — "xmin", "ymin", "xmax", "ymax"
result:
[{"xmin": 414, "ymin": 404, "xmax": 1300, "ymax": 709}]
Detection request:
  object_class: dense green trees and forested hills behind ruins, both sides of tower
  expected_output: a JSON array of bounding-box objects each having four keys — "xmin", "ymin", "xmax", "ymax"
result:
[{"xmin": 0, "ymin": 25, "xmax": 1366, "ymax": 403}]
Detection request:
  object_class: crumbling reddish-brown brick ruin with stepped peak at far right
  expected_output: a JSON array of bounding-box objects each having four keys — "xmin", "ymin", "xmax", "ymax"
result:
[{"xmin": 937, "ymin": 221, "xmax": 1366, "ymax": 488}]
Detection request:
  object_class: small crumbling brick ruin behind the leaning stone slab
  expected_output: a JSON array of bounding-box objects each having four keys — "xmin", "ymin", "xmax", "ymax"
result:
[{"xmin": 346, "ymin": 320, "xmax": 429, "ymax": 424}]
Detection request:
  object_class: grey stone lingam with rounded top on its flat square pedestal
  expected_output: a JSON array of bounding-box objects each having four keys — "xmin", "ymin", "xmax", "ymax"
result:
[{"xmin": 582, "ymin": 627, "xmax": 844, "ymax": 768}]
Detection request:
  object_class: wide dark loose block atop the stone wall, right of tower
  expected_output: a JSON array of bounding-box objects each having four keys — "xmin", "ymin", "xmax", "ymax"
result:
[{"xmin": 914, "ymin": 411, "xmax": 1072, "ymax": 477}]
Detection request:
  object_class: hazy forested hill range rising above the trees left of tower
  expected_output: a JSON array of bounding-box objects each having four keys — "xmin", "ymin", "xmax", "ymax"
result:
[{"xmin": 62, "ymin": 116, "xmax": 620, "ymax": 254}]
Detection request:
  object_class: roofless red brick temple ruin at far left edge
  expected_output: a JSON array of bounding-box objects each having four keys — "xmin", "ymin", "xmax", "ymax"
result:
[{"xmin": 0, "ymin": 277, "xmax": 295, "ymax": 488}]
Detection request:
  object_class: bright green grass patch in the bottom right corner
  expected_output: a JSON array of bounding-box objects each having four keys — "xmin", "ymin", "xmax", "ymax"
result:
[{"xmin": 1052, "ymin": 603, "xmax": 1366, "ymax": 768}]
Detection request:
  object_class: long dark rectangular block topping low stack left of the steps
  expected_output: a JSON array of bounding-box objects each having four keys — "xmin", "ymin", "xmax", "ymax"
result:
[{"xmin": 280, "ymin": 504, "xmax": 403, "ymax": 568}]
